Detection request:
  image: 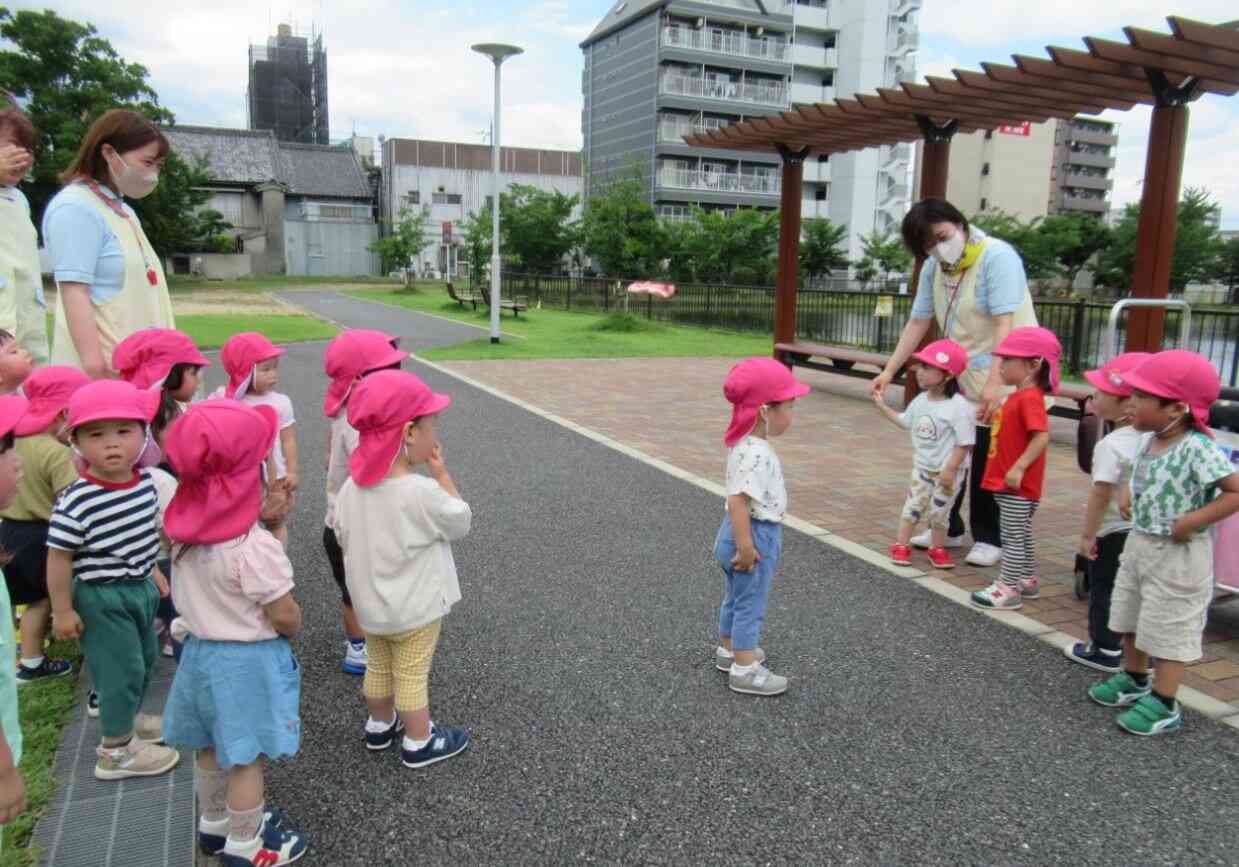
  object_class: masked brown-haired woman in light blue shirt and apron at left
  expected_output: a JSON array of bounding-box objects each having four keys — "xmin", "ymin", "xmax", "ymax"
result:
[{"xmin": 43, "ymin": 109, "xmax": 176, "ymax": 379}]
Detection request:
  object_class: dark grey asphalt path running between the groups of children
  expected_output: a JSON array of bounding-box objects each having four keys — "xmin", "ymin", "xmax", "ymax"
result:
[{"xmin": 234, "ymin": 294, "xmax": 1239, "ymax": 866}]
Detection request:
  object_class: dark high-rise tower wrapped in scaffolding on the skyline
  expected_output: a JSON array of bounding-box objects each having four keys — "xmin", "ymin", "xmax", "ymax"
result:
[{"xmin": 247, "ymin": 24, "xmax": 330, "ymax": 145}]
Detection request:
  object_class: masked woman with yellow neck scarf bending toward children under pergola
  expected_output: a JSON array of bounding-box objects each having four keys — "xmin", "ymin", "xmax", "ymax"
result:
[{"xmin": 872, "ymin": 198, "xmax": 1037, "ymax": 566}]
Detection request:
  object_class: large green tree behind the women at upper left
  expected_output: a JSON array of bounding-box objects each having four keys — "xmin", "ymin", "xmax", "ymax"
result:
[{"xmin": 0, "ymin": 6, "xmax": 209, "ymax": 255}]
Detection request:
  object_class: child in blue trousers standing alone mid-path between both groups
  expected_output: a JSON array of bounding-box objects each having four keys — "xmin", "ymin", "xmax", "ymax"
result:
[{"xmin": 714, "ymin": 358, "xmax": 809, "ymax": 696}]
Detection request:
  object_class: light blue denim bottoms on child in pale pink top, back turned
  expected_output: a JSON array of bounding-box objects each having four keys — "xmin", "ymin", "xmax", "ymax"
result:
[{"xmin": 164, "ymin": 635, "xmax": 301, "ymax": 768}]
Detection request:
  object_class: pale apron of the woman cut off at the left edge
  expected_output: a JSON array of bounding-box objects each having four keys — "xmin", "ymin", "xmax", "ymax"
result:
[{"xmin": 0, "ymin": 188, "xmax": 47, "ymax": 365}]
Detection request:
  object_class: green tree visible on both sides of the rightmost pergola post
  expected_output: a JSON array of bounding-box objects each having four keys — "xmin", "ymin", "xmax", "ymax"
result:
[{"xmin": 1094, "ymin": 187, "xmax": 1225, "ymax": 292}]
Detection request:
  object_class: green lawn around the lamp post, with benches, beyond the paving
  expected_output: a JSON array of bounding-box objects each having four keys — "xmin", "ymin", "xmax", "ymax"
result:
[{"xmin": 349, "ymin": 284, "xmax": 771, "ymax": 362}]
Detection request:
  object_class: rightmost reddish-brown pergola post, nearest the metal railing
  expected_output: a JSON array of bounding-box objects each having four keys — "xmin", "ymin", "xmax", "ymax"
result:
[{"xmin": 1125, "ymin": 69, "xmax": 1197, "ymax": 352}]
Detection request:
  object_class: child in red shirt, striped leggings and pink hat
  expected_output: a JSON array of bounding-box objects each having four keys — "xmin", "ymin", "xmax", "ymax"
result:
[{"xmin": 971, "ymin": 327, "xmax": 1063, "ymax": 611}]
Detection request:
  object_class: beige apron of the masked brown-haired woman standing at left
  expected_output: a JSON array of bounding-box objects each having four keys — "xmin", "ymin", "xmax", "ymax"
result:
[{"xmin": 52, "ymin": 183, "xmax": 176, "ymax": 367}]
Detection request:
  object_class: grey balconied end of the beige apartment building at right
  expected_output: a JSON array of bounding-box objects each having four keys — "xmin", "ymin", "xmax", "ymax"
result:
[{"xmin": 1049, "ymin": 118, "xmax": 1119, "ymax": 218}]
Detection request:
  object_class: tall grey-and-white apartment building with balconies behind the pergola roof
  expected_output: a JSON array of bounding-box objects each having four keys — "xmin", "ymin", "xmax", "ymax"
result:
[{"xmin": 581, "ymin": 0, "xmax": 921, "ymax": 254}]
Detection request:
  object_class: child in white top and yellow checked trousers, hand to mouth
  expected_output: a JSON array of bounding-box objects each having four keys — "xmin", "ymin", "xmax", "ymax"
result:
[{"xmin": 335, "ymin": 370, "xmax": 473, "ymax": 768}]
